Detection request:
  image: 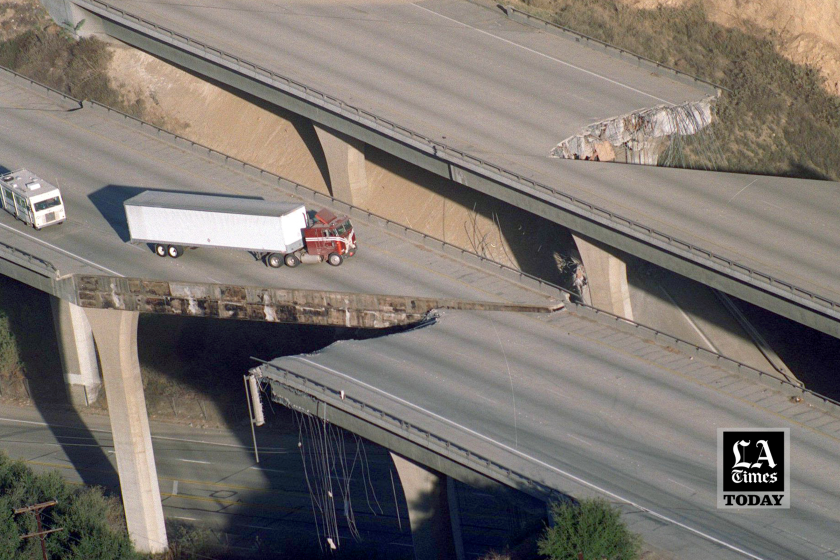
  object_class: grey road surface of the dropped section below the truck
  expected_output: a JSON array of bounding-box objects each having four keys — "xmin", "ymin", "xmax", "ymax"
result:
[{"xmin": 262, "ymin": 308, "xmax": 840, "ymax": 560}]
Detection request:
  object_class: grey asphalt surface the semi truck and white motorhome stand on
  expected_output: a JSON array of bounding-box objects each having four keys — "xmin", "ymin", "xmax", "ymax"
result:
[{"xmin": 0, "ymin": 71, "xmax": 559, "ymax": 304}]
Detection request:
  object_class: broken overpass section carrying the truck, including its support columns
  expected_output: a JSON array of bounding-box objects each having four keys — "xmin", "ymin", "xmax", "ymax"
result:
[{"xmin": 0, "ymin": 71, "xmax": 562, "ymax": 550}]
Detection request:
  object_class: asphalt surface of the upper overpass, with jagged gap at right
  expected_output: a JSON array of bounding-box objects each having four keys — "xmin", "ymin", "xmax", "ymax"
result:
[{"xmin": 87, "ymin": 0, "xmax": 840, "ymax": 310}]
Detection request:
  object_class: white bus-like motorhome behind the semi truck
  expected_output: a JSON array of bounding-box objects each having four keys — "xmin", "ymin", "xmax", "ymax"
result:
[{"xmin": 0, "ymin": 169, "xmax": 66, "ymax": 229}]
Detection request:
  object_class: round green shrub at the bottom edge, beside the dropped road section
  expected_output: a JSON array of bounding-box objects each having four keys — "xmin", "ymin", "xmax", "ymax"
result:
[{"xmin": 537, "ymin": 498, "xmax": 641, "ymax": 560}]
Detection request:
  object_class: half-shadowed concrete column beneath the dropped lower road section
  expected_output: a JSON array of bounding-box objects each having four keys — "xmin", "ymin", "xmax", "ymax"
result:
[{"xmin": 391, "ymin": 452, "xmax": 464, "ymax": 560}]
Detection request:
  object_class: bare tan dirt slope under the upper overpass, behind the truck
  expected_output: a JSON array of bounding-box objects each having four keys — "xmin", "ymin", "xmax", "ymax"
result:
[{"xmin": 109, "ymin": 46, "xmax": 570, "ymax": 282}]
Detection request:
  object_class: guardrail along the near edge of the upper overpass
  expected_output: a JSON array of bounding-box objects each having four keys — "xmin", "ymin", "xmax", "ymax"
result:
[{"xmin": 73, "ymin": 0, "xmax": 840, "ymax": 319}]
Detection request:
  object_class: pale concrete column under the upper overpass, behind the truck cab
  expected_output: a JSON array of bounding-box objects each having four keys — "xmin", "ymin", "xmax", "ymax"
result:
[{"xmin": 313, "ymin": 123, "xmax": 368, "ymax": 207}]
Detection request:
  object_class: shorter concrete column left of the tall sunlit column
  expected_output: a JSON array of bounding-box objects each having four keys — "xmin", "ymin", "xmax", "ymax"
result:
[{"xmin": 50, "ymin": 296, "xmax": 102, "ymax": 406}]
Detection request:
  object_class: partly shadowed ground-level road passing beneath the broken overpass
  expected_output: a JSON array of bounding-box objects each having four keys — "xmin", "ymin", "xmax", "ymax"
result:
[{"xmin": 0, "ymin": 402, "xmax": 545, "ymax": 559}]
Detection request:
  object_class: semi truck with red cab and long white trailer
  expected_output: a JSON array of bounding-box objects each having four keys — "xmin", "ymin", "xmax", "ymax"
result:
[{"xmin": 123, "ymin": 190, "xmax": 356, "ymax": 268}]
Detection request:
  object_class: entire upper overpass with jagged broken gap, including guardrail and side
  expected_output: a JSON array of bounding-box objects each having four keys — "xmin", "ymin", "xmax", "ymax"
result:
[{"xmin": 45, "ymin": 0, "xmax": 840, "ymax": 336}]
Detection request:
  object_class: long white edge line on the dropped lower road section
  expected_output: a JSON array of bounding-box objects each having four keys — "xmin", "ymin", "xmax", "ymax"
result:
[{"xmin": 292, "ymin": 356, "xmax": 765, "ymax": 560}]
